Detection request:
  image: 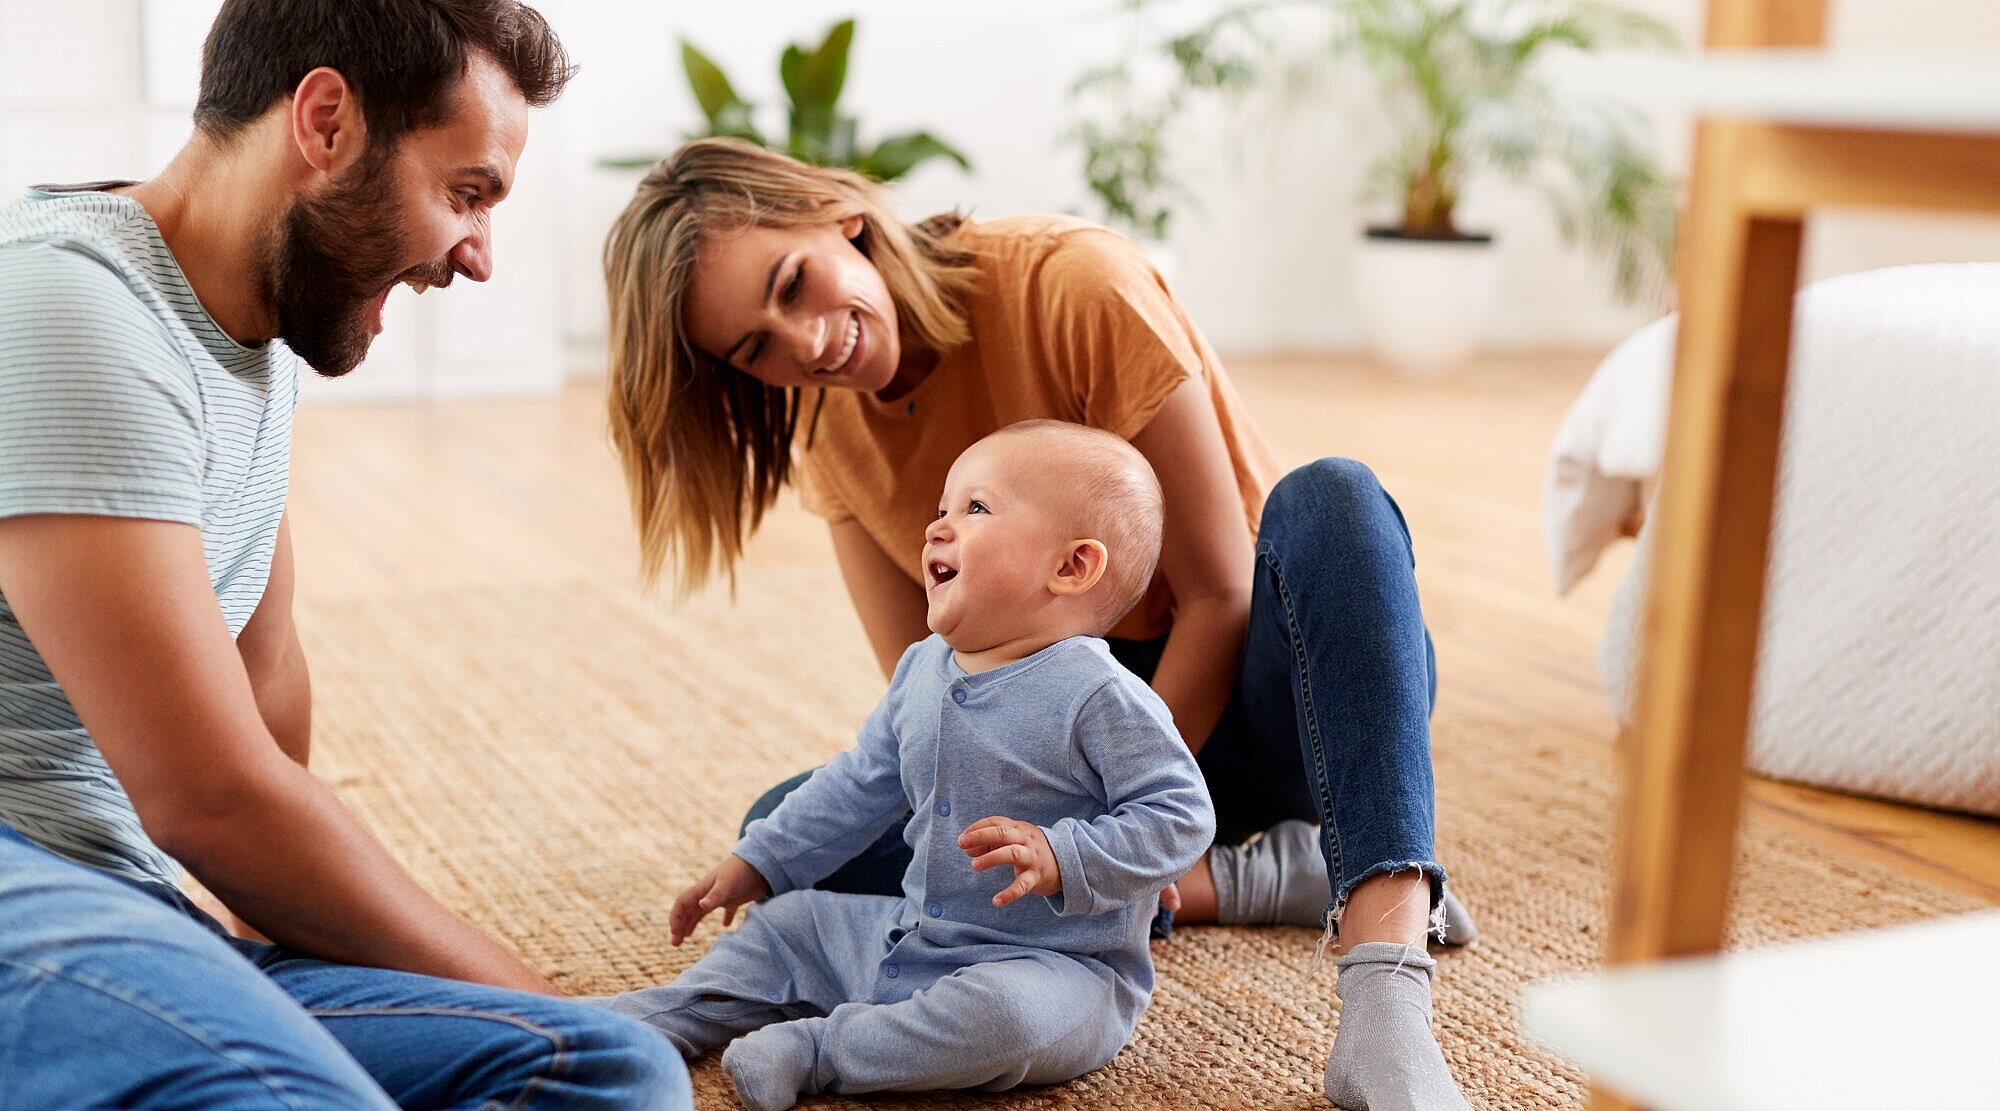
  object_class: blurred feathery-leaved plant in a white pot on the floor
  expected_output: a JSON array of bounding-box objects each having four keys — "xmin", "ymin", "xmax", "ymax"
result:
[{"xmin": 1124, "ymin": 0, "xmax": 1676, "ymax": 376}]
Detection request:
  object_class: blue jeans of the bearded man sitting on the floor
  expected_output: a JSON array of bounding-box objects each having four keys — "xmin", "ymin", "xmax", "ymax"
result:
[{"xmin": 0, "ymin": 825, "xmax": 694, "ymax": 1111}]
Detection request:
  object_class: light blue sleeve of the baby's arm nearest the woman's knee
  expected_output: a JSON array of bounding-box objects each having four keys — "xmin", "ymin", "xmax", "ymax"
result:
[{"xmin": 1044, "ymin": 681, "xmax": 1216, "ymax": 915}]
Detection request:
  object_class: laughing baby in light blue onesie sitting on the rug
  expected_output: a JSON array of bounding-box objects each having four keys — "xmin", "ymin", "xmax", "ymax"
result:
[{"xmin": 610, "ymin": 422, "xmax": 1214, "ymax": 1111}]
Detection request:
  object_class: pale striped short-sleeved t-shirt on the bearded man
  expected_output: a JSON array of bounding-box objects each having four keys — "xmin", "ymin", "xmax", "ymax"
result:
[{"xmin": 0, "ymin": 186, "xmax": 298, "ymax": 883}]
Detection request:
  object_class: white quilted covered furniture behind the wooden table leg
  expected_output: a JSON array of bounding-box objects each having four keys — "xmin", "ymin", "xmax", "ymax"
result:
[{"xmin": 1544, "ymin": 262, "xmax": 2000, "ymax": 815}]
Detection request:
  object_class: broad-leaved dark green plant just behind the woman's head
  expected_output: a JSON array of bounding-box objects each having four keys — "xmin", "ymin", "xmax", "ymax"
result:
[{"xmin": 600, "ymin": 20, "xmax": 972, "ymax": 182}]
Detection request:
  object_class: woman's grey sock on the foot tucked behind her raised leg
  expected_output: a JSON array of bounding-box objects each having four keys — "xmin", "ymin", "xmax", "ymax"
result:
[{"xmin": 1208, "ymin": 819, "xmax": 1478, "ymax": 945}]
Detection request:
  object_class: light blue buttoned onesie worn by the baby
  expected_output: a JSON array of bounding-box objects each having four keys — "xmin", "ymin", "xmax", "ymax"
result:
[{"xmin": 610, "ymin": 637, "xmax": 1214, "ymax": 1093}]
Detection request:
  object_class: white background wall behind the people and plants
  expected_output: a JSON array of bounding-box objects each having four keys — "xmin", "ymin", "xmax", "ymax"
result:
[{"xmin": 11, "ymin": 0, "xmax": 2000, "ymax": 398}]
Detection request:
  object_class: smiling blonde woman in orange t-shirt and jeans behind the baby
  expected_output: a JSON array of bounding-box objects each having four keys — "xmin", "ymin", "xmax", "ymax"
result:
[{"xmin": 604, "ymin": 140, "xmax": 1470, "ymax": 1111}]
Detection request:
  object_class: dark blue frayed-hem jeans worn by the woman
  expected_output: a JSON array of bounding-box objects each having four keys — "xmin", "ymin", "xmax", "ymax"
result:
[{"xmin": 744, "ymin": 460, "xmax": 1444, "ymax": 931}]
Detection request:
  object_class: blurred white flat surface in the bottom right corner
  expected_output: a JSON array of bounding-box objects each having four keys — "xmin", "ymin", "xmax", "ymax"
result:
[{"xmin": 1520, "ymin": 911, "xmax": 2000, "ymax": 1111}]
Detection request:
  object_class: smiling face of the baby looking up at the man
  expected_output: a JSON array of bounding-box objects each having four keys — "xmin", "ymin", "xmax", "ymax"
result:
[{"xmin": 924, "ymin": 436, "xmax": 1070, "ymax": 651}]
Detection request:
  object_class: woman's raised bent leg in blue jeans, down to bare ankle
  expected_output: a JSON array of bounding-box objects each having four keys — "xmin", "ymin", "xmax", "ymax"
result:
[{"xmin": 1238, "ymin": 460, "xmax": 1444, "ymax": 931}]
